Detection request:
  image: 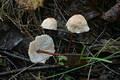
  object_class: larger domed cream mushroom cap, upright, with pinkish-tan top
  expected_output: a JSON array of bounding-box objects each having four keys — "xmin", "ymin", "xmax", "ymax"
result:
[{"xmin": 66, "ymin": 14, "xmax": 90, "ymax": 33}]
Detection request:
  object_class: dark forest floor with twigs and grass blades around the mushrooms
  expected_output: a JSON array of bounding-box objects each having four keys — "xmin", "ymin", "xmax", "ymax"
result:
[{"xmin": 0, "ymin": 0, "xmax": 120, "ymax": 80}]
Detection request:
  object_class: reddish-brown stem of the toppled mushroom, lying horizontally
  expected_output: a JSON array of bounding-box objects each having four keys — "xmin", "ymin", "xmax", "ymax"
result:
[{"xmin": 37, "ymin": 50, "xmax": 85, "ymax": 56}]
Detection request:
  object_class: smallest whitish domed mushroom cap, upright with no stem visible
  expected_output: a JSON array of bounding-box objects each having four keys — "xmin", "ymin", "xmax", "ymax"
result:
[{"xmin": 41, "ymin": 18, "xmax": 57, "ymax": 30}]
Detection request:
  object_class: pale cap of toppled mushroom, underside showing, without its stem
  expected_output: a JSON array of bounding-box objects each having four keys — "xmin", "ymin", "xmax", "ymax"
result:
[{"xmin": 28, "ymin": 35, "xmax": 55, "ymax": 63}]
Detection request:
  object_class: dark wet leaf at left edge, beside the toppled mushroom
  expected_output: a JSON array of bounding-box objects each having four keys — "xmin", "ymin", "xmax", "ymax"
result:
[{"xmin": 0, "ymin": 24, "xmax": 23, "ymax": 50}]
